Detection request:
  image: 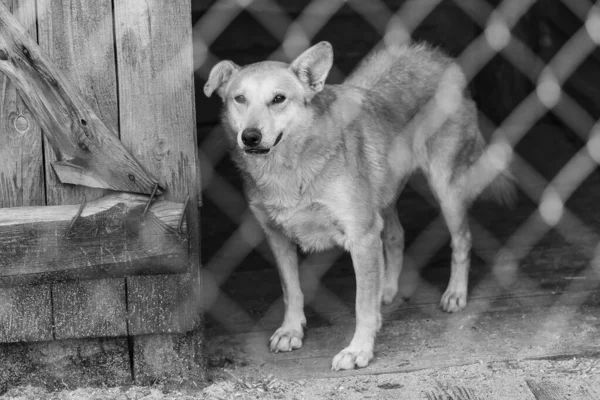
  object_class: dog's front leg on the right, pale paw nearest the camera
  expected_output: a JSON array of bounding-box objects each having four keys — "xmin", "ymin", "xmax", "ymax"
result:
[{"xmin": 331, "ymin": 215, "xmax": 385, "ymax": 371}]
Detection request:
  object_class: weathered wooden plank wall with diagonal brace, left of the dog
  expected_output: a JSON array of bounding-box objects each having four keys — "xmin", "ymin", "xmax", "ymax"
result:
[{"xmin": 0, "ymin": 0, "xmax": 202, "ymax": 381}]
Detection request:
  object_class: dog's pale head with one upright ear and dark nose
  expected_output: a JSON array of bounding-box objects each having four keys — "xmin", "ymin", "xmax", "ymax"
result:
[{"xmin": 204, "ymin": 42, "xmax": 333, "ymax": 155}]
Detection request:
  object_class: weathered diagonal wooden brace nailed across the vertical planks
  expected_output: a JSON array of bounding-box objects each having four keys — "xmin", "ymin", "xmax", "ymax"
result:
[{"xmin": 0, "ymin": 3, "xmax": 157, "ymax": 194}]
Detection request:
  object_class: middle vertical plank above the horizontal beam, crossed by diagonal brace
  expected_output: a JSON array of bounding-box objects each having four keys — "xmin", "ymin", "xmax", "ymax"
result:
[{"xmin": 39, "ymin": 0, "xmax": 119, "ymax": 205}]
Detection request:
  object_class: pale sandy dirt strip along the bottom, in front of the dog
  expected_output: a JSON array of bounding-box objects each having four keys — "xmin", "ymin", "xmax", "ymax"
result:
[{"xmin": 0, "ymin": 358, "xmax": 600, "ymax": 400}]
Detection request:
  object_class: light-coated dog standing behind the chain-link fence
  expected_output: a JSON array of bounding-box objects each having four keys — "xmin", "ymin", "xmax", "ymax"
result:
[{"xmin": 204, "ymin": 42, "xmax": 513, "ymax": 371}]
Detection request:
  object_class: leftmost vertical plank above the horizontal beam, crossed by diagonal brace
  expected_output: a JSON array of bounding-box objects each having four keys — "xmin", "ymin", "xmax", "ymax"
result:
[{"xmin": 0, "ymin": 0, "xmax": 44, "ymax": 208}]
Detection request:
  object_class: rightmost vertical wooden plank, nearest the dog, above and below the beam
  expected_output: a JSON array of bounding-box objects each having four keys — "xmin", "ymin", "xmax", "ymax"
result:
[{"xmin": 114, "ymin": 0, "xmax": 203, "ymax": 381}]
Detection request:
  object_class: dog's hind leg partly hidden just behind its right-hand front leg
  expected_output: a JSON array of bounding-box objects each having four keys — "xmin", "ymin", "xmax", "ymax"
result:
[{"xmin": 382, "ymin": 202, "xmax": 404, "ymax": 304}]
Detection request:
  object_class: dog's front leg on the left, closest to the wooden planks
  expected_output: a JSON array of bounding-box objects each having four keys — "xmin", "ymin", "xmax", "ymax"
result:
[{"xmin": 264, "ymin": 226, "xmax": 306, "ymax": 353}]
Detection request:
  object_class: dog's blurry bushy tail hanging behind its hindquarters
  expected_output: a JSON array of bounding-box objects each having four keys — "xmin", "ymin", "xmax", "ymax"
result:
[{"xmin": 463, "ymin": 142, "xmax": 517, "ymax": 206}]
